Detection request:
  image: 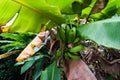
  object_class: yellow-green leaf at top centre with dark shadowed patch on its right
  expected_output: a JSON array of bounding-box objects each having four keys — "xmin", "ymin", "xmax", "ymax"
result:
[{"xmin": 46, "ymin": 0, "xmax": 91, "ymax": 14}]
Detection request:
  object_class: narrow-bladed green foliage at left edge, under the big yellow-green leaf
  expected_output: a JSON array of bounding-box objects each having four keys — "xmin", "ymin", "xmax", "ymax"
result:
[{"xmin": 0, "ymin": 33, "xmax": 35, "ymax": 52}]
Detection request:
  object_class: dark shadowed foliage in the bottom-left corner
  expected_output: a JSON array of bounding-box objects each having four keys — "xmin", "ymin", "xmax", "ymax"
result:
[{"xmin": 0, "ymin": 53, "xmax": 24, "ymax": 80}]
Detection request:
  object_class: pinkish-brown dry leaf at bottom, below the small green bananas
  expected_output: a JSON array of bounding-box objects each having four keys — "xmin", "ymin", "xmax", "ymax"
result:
[{"xmin": 63, "ymin": 59, "xmax": 97, "ymax": 80}]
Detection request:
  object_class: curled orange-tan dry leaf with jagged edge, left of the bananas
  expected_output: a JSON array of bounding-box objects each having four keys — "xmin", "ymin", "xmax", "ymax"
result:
[{"xmin": 16, "ymin": 32, "xmax": 48, "ymax": 62}]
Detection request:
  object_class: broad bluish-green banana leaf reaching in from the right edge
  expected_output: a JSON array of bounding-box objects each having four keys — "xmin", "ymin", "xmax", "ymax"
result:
[{"xmin": 77, "ymin": 18, "xmax": 120, "ymax": 49}]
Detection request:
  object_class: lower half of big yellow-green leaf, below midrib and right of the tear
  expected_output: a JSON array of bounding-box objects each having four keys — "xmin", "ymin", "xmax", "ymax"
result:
[{"xmin": 9, "ymin": 7, "xmax": 55, "ymax": 32}]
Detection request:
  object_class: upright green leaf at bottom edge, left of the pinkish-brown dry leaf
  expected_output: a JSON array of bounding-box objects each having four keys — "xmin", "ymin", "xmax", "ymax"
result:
[{"xmin": 40, "ymin": 61, "xmax": 61, "ymax": 80}]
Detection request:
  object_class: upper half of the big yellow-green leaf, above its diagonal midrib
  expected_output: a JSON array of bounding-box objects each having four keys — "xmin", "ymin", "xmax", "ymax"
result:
[{"xmin": 14, "ymin": 0, "xmax": 65, "ymax": 24}]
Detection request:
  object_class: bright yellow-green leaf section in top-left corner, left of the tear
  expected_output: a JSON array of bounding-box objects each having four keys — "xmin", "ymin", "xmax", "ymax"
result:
[{"xmin": 0, "ymin": 0, "xmax": 20, "ymax": 26}]
